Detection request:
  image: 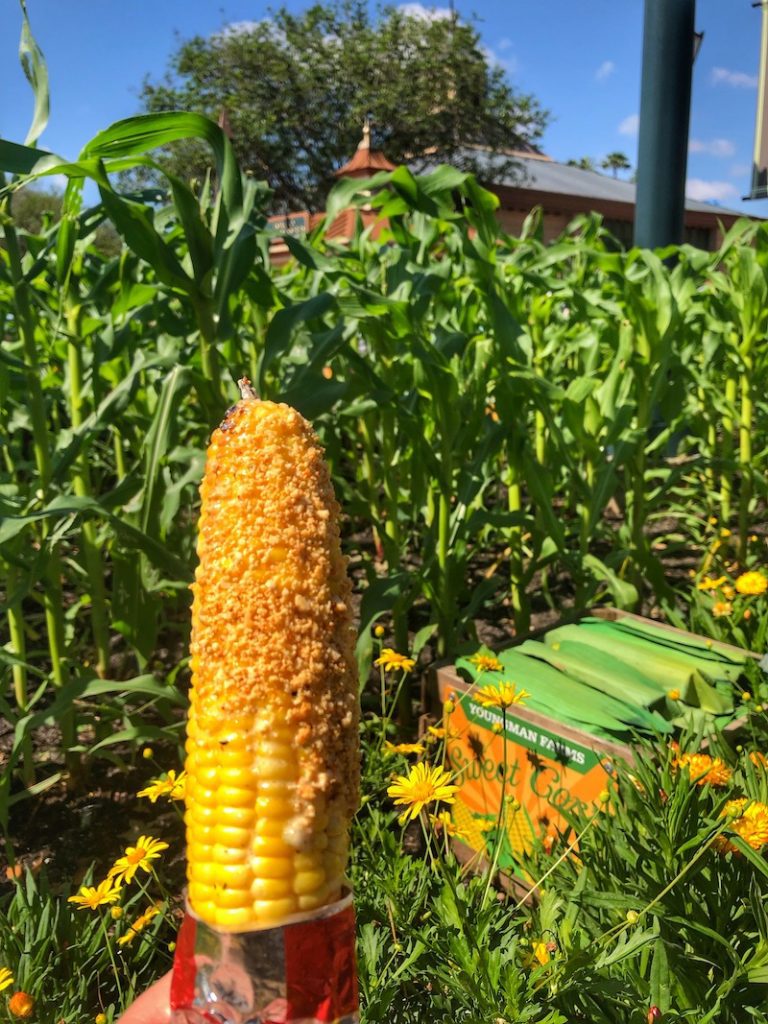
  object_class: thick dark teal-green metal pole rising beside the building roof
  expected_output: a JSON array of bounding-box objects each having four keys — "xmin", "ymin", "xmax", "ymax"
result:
[{"xmin": 635, "ymin": 0, "xmax": 696, "ymax": 249}]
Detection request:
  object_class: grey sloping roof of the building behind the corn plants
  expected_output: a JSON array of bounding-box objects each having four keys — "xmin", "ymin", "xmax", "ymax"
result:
[{"xmin": 479, "ymin": 154, "xmax": 744, "ymax": 217}]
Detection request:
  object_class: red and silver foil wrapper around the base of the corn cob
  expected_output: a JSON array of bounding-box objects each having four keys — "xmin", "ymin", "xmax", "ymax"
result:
[{"xmin": 171, "ymin": 893, "xmax": 359, "ymax": 1024}]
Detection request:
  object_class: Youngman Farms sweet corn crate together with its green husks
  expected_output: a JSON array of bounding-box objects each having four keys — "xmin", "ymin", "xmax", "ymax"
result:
[{"xmin": 437, "ymin": 609, "xmax": 754, "ymax": 874}]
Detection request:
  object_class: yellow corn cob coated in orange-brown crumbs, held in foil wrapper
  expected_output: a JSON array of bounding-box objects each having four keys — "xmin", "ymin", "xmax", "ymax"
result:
[{"xmin": 185, "ymin": 390, "xmax": 359, "ymax": 928}]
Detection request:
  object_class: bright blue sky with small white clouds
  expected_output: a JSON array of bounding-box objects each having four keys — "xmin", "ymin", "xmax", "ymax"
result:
[{"xmin": 0, "ymin": 0, "xmax": 768, "ymax": 217}]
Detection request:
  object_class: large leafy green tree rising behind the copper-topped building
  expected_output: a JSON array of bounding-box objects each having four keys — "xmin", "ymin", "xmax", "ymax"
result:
[{"xmin": 141, "ymin": 0, "xmax": 547, "ymax": 210}]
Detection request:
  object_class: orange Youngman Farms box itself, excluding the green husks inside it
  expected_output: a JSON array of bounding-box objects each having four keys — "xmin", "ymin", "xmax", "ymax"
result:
[{"xmin": 436, "ymin": 609, "xmax": 757, "ymax": 883}]
